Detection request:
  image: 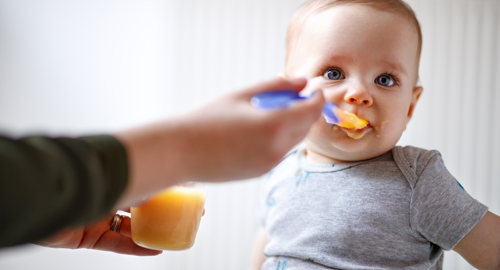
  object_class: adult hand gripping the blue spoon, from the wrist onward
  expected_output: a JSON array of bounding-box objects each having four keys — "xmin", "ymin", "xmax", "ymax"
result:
[{"xmin": 176, "ymin": 79, "xmax": 324, "ymax": 182}]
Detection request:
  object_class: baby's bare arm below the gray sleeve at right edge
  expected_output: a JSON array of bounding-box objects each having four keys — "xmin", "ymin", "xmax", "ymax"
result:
[{"xmin": 453, "ymin": 211, "xmax": 500, "ymax": 269}]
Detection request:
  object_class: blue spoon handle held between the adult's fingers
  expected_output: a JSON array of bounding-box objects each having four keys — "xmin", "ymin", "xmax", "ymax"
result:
[{"xmin": 251, "ymin": 89, "xmax": 339, "ymax": 124}]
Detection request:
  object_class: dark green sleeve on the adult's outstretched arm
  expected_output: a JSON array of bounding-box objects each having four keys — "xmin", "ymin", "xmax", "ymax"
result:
[{"xmin": 0, "ymin": 136, "xmax": 128, "ymax": 247}]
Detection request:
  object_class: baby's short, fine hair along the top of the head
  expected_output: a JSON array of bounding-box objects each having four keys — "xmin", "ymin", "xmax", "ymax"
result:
[{"xmin": 285, "ymin": 0, "xmax": 422, "ymax": 77}]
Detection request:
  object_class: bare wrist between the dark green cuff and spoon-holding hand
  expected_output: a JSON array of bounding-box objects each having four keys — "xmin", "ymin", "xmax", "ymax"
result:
[{"xmin": 115, "ymin": 119, "xmax": 188, "ymax": 208}]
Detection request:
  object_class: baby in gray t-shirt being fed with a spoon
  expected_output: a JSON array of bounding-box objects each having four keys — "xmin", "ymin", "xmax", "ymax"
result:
[{"xmin": 253, "ymin": 0, "xmax": 500, "ymax": 270}]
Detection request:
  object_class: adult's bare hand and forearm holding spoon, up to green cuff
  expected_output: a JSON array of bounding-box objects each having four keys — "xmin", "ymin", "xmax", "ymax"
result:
[{"xmin": 116, "ymin": 79, "xmax": 324, "ymax": 207}]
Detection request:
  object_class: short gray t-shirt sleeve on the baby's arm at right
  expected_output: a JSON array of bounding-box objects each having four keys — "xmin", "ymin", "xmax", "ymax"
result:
[{"xmin": 411, "ymin": 154, "xmax": 488, "ymax": 250}]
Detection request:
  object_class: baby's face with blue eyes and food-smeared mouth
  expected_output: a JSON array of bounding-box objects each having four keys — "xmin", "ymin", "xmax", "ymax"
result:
[{"xmin": 286, "ymin": 4, "xmax": 422, "ymax": 163}]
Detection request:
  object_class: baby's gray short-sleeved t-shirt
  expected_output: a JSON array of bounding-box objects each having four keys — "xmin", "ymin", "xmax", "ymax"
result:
[{"xmin": 260, "ymin": 146, "xmax": 487, "ymax": 270}]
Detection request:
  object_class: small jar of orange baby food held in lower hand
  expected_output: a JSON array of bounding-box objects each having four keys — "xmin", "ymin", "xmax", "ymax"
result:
[{"xmin": 131, "ymin": 186, "xmax": 205, "ymax": 250}]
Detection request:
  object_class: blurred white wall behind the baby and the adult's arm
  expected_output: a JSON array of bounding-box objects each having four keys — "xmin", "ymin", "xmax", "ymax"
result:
[{"xmin": 0, "ymin": 0, "xmax": 500, "ymax": 270}]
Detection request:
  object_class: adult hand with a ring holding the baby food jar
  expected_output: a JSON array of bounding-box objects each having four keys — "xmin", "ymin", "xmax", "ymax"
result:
[{"xmin": 35, "ymin": 215, "xmax": 162, "ymax": 256}]
